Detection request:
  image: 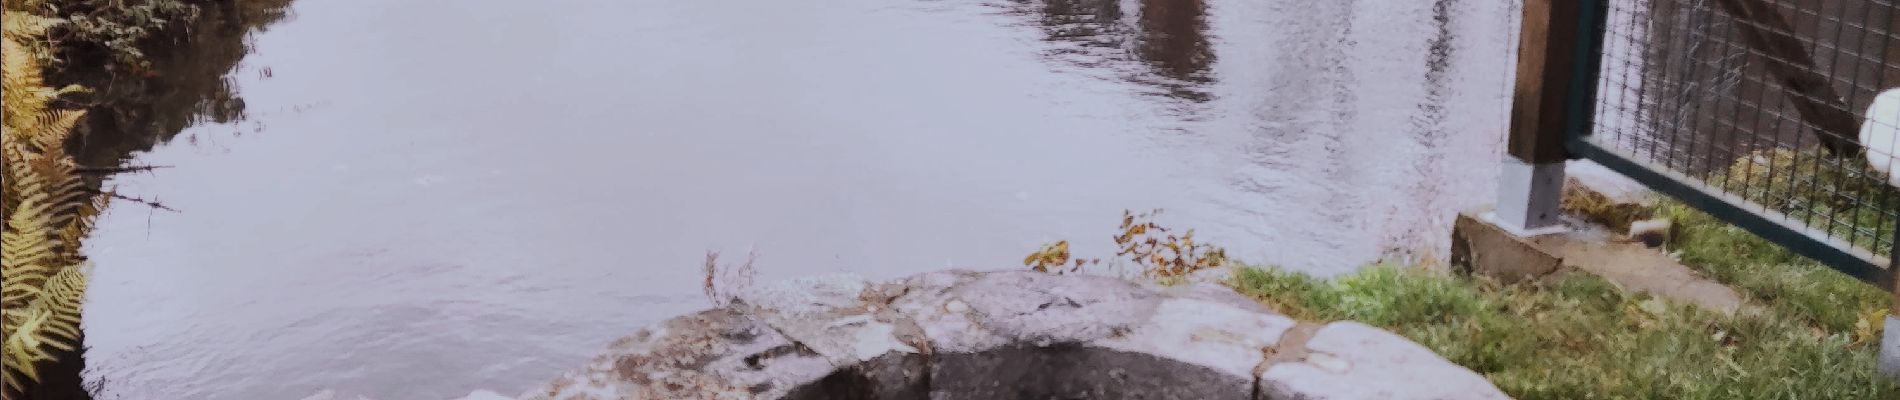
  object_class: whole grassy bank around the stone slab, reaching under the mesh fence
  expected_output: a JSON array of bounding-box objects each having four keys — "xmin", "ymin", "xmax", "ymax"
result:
[{"xmin": 1229, "ymin": 171, "xmax": 1900, "ymax": 398}]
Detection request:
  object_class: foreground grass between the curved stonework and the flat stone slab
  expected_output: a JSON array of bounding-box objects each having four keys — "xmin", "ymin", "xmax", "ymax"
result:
[{"xmin": 1231, "ymin": 267, "xmax": 1900, "ymax": 398}]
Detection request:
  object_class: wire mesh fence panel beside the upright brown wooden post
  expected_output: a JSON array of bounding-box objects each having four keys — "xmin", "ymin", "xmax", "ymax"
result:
[{"xmin": 1571, "ymin": 0, "xmax": 1900, "ymax": 286}]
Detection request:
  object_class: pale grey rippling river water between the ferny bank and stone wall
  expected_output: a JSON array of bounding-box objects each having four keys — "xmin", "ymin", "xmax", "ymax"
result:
[{"xmin": 86, "ymin": 0, "xmax": 1516, "ymax": 400}]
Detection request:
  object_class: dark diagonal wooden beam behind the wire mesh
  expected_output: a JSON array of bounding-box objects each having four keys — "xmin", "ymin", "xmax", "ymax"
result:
[{"xmin": 1716, "ymin": 0, "xmax": 1862, "ymax": 157}]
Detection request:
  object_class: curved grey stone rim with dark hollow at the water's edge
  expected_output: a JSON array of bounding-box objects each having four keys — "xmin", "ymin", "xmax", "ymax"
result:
[{"xmin": 521, "ymin": 271, "xmax": 1507, "ymax": 400}]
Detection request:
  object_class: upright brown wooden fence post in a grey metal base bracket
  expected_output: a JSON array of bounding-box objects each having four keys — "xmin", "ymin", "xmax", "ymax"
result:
[{"xmin": 1493, "ymin": 0, "xmax": 1585, "ymax": 235}]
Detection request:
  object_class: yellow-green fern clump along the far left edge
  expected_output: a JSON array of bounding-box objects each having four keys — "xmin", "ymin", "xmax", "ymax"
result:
[{"xmin": 0, "ymin": 0, "xmax": 99, "ymax": 387}]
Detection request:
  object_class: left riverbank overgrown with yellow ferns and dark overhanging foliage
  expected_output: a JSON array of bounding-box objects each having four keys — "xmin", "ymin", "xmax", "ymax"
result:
[{"xmin": 4, "ymin": 0, "xmax": 289, "ymax": 400}]
